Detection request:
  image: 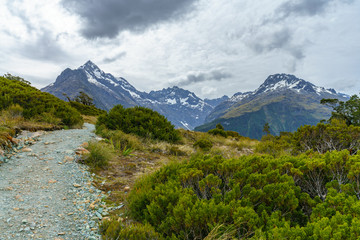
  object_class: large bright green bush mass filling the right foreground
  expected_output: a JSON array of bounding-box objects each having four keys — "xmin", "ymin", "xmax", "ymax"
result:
[{"xmin": 117, "ymin": 150, "xmax": 360, "ymax": 239}]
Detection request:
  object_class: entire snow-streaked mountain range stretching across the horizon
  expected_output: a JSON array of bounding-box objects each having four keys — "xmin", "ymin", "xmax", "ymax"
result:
[{"xmin": 42, "ymin": 61, "xmax": 349, "ymax": 139}]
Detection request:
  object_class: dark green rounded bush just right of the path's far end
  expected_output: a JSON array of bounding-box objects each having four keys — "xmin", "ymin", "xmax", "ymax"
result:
[{"xmin": 96, "ymin": 105, "xmax": 180, "ymax": 143}]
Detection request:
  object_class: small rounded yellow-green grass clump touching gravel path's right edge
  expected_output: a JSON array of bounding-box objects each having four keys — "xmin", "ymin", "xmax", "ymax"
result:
[{"xmin": 84, "ymin": 142, "xmax": 114, "ymax": 169}]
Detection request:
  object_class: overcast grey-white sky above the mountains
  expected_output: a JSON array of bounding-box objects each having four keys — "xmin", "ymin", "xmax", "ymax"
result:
[{"xmin": 0, "ymin": 0, "xmax": 360, "ymax": 98}]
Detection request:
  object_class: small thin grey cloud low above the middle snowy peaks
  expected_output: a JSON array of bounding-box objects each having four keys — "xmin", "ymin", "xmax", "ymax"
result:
[{"xmin": 176, "ymin": 70, "xmax": 232, "ymax": 86}]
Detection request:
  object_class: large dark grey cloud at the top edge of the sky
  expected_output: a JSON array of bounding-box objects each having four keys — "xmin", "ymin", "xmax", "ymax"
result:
[{"xmin": 62, "ymin": 0, "xmax": 197, "ymax": 39}]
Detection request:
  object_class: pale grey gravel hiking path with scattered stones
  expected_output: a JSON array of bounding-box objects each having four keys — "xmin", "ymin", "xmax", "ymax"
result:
[{"xmin": 0, "ymin": 124, "xmax": 109, "ymax": 240}]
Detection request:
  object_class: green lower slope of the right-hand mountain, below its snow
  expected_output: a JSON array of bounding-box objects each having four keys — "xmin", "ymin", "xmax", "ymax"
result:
[{"xmin": 195, "ymin": 90, "xmax": 331, "ymax": 139}]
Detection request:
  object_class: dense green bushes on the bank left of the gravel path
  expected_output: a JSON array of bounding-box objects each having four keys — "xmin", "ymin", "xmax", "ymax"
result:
[{"xmin": 0, "ymin": 77, "xmax": 83, "ymax": 126}]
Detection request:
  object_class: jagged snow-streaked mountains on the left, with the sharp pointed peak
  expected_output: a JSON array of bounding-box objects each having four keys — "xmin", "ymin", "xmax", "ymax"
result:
[{"xmin": 42, "ymin": 61, "xmax": 228, "ymax": 129}]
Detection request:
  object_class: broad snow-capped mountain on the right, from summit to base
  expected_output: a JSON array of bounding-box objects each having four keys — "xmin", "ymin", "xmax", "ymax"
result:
[{"xmin": 195, "ymin": 74, "xmax": 349, "ymax": 139}]
